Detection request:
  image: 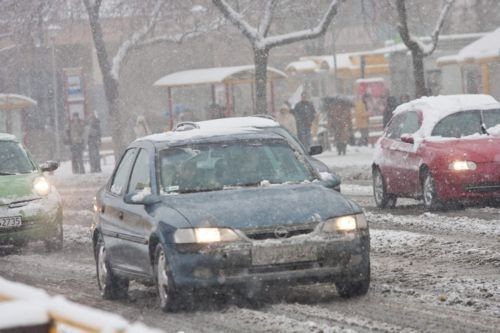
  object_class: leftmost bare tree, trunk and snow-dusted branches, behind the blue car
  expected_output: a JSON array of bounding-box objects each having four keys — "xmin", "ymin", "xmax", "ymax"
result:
[{"xmin": 83, "ymin": 0, "xmax": 221, "ymax": 158}]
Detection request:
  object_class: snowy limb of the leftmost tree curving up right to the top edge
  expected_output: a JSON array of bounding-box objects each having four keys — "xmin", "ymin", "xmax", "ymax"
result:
[{"xmin": 111, "ymin": 0, "xmax": 165, "ymax": 80}]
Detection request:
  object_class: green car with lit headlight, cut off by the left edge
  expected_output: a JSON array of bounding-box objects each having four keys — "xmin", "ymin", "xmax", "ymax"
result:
[{"xmin": 0, "ymin": 133, "xmax": 63, "ymax": 251}]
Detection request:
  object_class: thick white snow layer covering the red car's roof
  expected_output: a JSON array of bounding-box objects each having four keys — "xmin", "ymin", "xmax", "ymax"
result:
[{"xmin": 394, "ymin": 94, "xmax": 500, "ymax": 137}]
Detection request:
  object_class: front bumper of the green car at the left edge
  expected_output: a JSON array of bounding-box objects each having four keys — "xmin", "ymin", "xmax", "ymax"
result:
[{"xmin": 0, "ymin": 193, "xmax": 62, "ymax": 246}]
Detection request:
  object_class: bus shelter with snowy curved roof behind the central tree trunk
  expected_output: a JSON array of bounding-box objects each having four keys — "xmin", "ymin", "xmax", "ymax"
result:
[{"xmin": 154, "ymin": 65, "xmax": 287, "ymax": 128}]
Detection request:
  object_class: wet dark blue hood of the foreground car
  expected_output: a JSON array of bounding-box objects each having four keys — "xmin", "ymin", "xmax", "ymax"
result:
[{"xmin": 164, "ymin": 184, "xmax": 361, "ymax": 229}]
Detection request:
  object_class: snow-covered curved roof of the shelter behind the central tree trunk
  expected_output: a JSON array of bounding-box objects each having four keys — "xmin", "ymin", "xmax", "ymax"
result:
[{"xmin": 154, "ymin": 65, "xmax": 287, "ymax": 87}]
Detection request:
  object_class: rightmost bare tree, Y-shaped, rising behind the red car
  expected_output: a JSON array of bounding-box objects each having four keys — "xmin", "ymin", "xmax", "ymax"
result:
[{"xmin": 396, "ymin": 0, "xmax": 455, "ymax": 98}]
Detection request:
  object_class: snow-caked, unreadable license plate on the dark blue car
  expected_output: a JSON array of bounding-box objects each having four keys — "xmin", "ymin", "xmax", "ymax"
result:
[{"xmin": 252, "ymin": 244, "xmax": 318, "ymax": 265}]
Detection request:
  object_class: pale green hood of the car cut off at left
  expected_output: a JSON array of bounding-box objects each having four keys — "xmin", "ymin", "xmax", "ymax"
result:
[{"xmin": 0, "ymin": 172, "xmax": 40, "ymax": 205}]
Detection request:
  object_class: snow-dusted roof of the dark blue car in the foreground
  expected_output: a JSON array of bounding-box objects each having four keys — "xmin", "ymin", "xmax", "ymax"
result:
[{"xmin": 134, "ymin": 127, "xmax": 285, "ymax": 146}]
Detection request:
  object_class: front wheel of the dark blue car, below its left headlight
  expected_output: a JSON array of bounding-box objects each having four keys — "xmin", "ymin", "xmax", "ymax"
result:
[{"xmin": 155, "ymin": 245, "xmax": 179, "ymax": 312}]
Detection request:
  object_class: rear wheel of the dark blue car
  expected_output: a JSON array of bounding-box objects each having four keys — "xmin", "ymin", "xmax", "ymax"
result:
[{"xmin": 95, "ymin": 235, "xmax": 129, "ymax": 299}]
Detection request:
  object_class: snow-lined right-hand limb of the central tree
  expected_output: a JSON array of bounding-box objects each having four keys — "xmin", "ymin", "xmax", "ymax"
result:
[{"xmin": 264, "ymin": 0, "xmax": 346, "ymax": 48}]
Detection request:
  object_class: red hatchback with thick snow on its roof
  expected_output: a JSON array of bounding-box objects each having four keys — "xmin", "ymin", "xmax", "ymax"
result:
[{"xmin": 372, "ymin": 95, "xmax": 500, "ymax": 210}]
